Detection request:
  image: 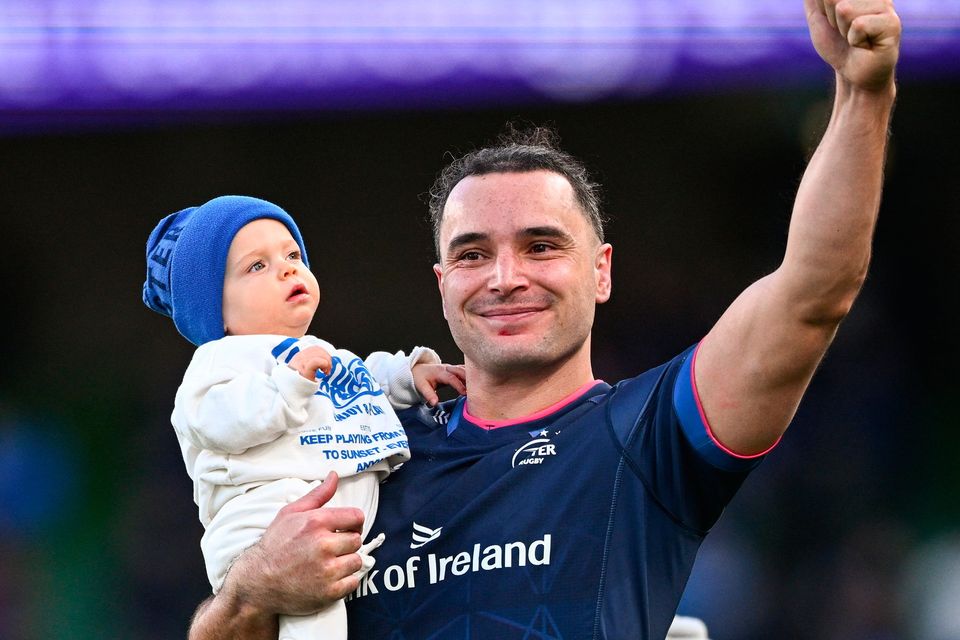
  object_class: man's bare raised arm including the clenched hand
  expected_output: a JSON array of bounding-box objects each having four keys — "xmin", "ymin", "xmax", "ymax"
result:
[{"xmin": 694, "ymin": 0, "xmax": 900, "ymax": 455}]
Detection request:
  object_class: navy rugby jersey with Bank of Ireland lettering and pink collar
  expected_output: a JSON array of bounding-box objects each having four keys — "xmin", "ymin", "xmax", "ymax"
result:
[{"xmin": 347, "ymin": 349, "xmax": 759, "ymax": 640}]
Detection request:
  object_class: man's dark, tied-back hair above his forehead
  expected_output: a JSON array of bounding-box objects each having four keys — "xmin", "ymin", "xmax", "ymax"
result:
[{"xmin": 428, "ymin": 123, "xmax": 605, "ymax": 257}]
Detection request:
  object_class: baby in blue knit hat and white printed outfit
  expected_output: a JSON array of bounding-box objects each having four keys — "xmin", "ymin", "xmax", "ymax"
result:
[{"xmin": 143, "ymin": 196, "xmax": 465, "ymax": 640}]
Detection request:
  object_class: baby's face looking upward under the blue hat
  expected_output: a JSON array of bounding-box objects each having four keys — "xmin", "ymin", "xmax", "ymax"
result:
[{"xmin": 223, "ymin": 218, "xmax": 320, "ymax": 338}]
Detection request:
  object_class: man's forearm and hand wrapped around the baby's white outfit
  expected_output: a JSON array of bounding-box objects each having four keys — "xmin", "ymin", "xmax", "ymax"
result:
[{"xmin": 189, "ymin": 472, "xmax": 363, "ymax": 640}]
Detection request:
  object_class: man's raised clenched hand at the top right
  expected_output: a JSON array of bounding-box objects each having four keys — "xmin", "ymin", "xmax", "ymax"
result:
[{"xmin": 804, "ymin": 0, "xmax": 900, "ymax": 91}]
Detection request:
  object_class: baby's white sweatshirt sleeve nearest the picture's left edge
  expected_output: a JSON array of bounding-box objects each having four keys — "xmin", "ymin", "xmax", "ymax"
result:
[{"xmin": 172, "ymin": 338, "xmax": 318, "ymax": 454}]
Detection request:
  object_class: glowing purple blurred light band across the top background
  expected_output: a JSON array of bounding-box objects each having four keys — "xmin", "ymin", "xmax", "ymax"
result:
[{"xmin": 0, "ymin": 0, "xmax": 960, "ymax": 128}]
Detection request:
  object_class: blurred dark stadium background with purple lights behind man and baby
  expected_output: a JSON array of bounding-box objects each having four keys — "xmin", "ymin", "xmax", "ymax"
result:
[{"xmin": 0, "ymin": 0, "xmax": 960, "ymax": 640}]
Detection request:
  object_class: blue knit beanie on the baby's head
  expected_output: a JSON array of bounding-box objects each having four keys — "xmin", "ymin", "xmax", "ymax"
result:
[{"xmin": 143, "ymin": 196, "xmax": 310, "ymax": 347}]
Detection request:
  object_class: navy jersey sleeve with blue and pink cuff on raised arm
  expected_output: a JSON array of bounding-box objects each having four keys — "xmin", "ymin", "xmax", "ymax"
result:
[{"xmin": 609, "ymin": 347, "xmax": 763, "ymax": 534}]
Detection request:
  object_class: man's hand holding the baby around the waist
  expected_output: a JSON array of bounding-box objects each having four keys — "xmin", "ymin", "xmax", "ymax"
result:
[{"xmin": 218, "ymin": 472, "xmax": 363, "ymax": 615}]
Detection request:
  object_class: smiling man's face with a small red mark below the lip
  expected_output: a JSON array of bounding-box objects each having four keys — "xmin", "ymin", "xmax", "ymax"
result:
[{"xmin": 434, "ymin": 171, "xmax": 612, "ymax": 377}]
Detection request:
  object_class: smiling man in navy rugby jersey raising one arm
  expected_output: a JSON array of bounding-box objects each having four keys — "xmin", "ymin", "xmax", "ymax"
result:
[{"xmin": 191, "ymin": 0, "xmax": 900, "ymax": 639}]
